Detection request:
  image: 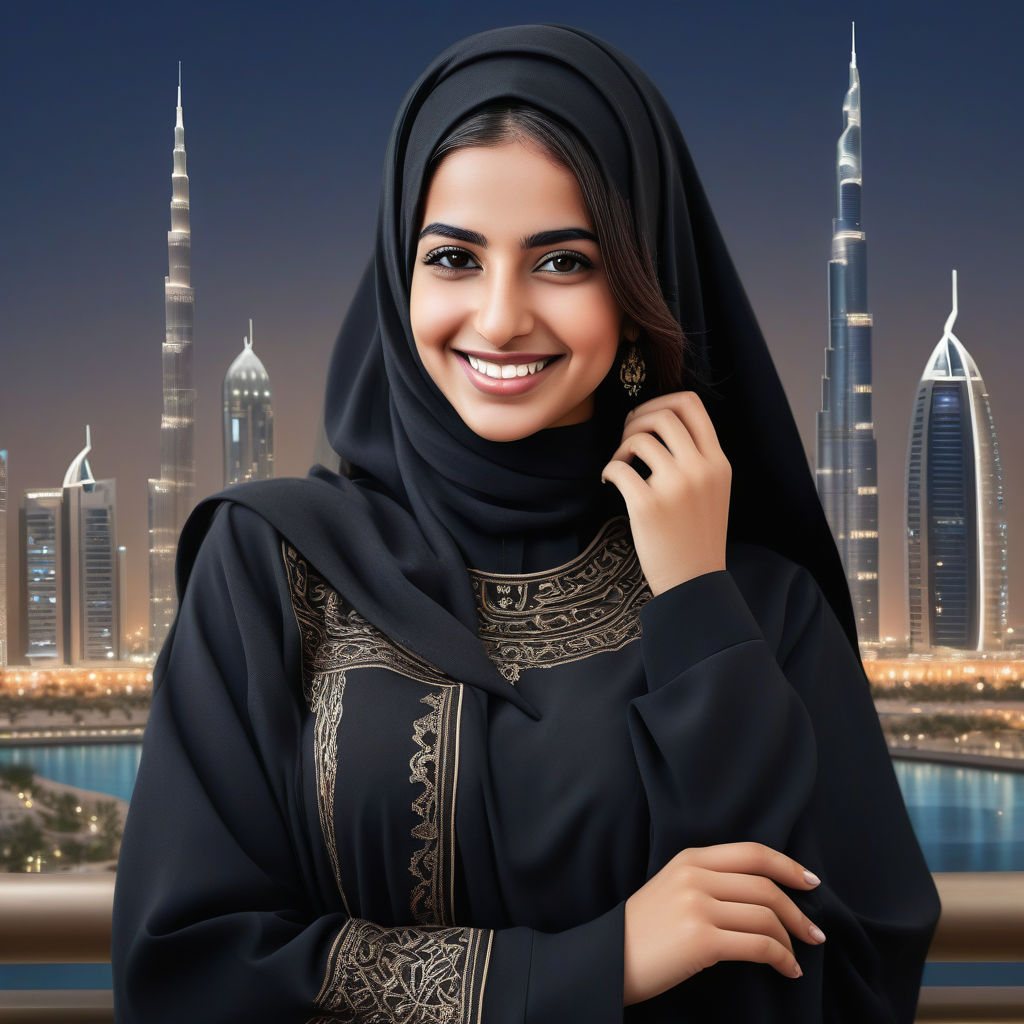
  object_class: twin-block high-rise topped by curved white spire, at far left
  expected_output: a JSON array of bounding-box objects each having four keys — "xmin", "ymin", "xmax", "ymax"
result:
[{"xmin": 19, "ymin": 427, "xmax": 123, "ymax": 665}]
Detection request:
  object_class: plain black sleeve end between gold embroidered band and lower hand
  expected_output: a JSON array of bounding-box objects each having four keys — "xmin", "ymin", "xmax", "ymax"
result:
[{"xmin": 483, "ymin": 900, "xmax": 626, "ymax": 1024}]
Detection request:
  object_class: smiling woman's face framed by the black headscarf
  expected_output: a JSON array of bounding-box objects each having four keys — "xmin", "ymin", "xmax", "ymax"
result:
[{"xmin": 410, "ymin": 142, "xmax": 623, "ymax": 441}]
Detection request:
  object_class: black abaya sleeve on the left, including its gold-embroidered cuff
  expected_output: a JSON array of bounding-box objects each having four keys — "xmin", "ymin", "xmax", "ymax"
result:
[{"xmin": 111, "ymin": 503, "xmax": 624, "ymax": 1024}]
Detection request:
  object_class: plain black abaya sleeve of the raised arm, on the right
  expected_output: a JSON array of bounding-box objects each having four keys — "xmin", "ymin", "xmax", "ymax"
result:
[{"xmin": 627, "ymin": 545, "xmax": 939, "ymax": 1024}]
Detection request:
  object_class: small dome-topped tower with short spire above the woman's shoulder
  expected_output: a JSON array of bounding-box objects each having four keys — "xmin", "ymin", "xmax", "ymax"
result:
[{"xmin": 223, "ymin": 321, "xmax": 273, "ymax": 486}]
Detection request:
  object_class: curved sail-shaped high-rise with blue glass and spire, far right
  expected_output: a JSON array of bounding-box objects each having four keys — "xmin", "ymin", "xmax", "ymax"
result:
[{"xmin": 905, "ymin": 270, "xmax": 1009, "ymax": 650}]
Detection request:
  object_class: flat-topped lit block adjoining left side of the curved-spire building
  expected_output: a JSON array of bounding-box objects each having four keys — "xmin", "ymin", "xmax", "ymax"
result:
[{"xmin": 18, "ymin": 488, "xmax": 66, "ymax": 665}]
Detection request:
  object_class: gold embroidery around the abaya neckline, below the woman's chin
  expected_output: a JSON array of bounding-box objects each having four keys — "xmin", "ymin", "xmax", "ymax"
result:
[{"xmin": 469, "ymin": 516, "xmax": 651, "ymax": 683}]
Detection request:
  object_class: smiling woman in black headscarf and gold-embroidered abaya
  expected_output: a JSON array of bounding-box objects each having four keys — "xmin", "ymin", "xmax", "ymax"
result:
[{"xmin": 112, "ymin": 19, "xmax": 939, "ymax": 1024}]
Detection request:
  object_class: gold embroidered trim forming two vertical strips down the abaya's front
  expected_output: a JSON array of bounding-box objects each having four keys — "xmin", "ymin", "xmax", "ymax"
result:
[{"xmin": 282, "ymin": 541, "xmax": 463, "ymax": 926}]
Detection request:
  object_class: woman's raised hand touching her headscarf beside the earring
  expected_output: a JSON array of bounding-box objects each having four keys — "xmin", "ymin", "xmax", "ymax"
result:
[{"xmin": 601, "ymin": 391, "xmax": 732, "ymax": 595}]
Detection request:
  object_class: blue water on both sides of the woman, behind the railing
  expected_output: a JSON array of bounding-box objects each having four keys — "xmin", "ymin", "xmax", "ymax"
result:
[{"xmin": 0, "ymin": 743, "xmax": 1024, "ymax": 989}]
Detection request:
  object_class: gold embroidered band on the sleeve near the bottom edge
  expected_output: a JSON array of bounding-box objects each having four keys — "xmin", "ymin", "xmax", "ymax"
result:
[{"xmin": 310, "ymin": 918, "xmax": 495, "ymax": 1024}]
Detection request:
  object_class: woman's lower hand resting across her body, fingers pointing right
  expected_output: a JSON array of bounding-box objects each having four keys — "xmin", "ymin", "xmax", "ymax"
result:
[{"xmin": 623, "ymin": 843, "xmax": 824, "ymax": 1006}]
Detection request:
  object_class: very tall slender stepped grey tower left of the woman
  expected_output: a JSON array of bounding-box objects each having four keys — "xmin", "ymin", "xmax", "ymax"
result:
[{"xmin": 150, "ymin": 62, "xmax": 196, "ymax": 652}]
